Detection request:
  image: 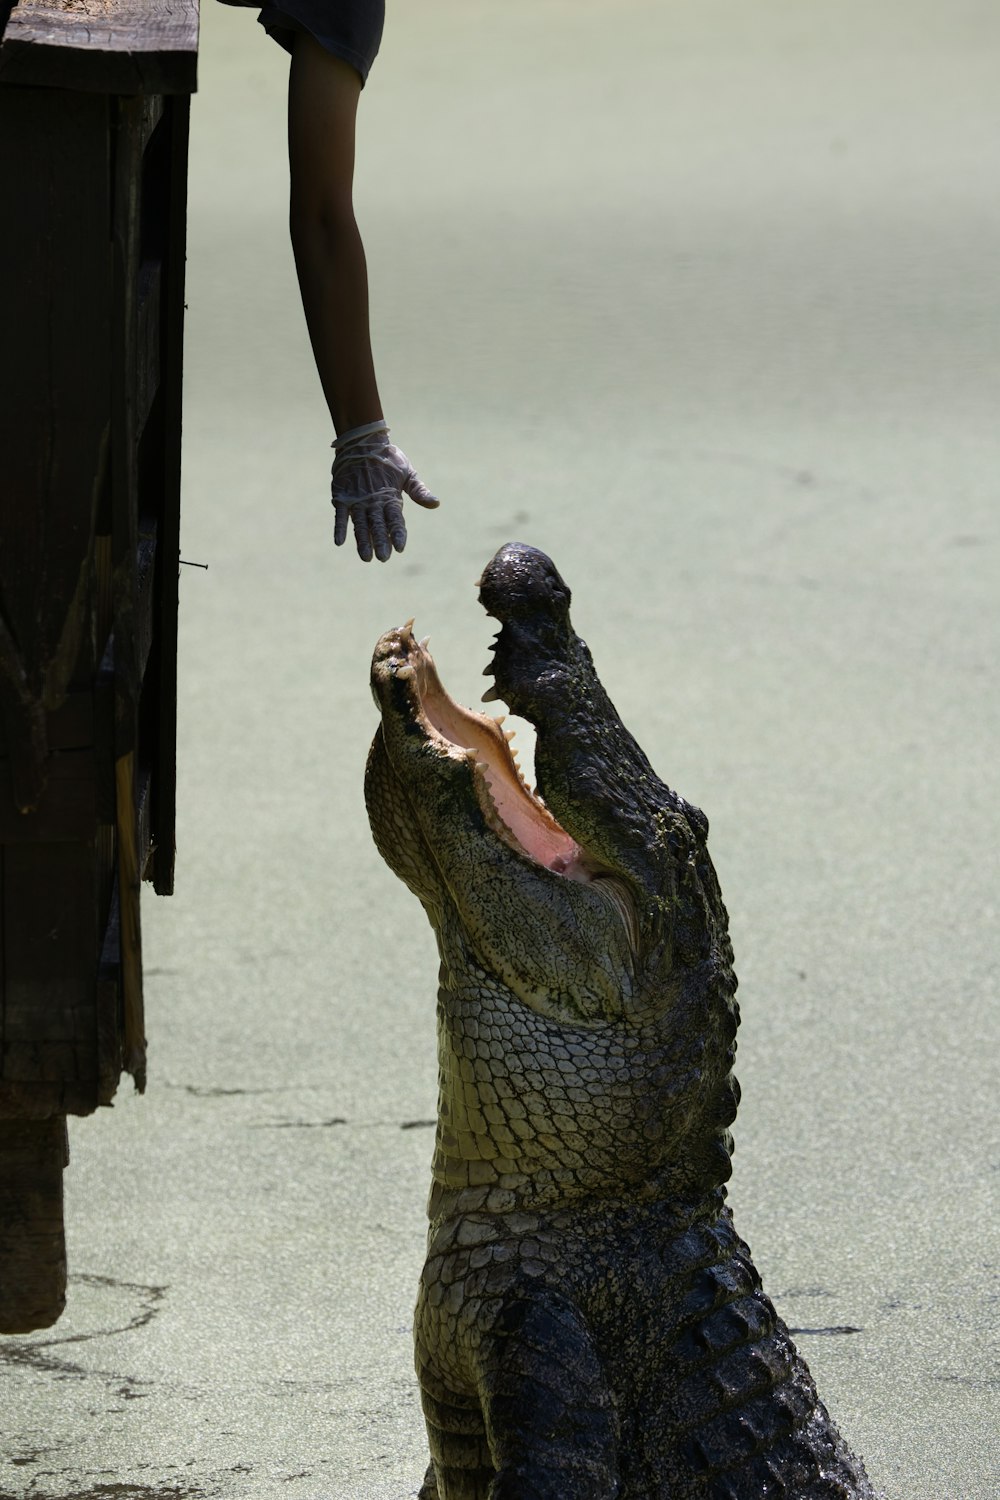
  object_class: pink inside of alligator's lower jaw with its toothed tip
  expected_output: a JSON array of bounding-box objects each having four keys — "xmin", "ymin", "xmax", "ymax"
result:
[{"xmin": 372, "ymin": 621, "xmax": 592, "ymax": 881}]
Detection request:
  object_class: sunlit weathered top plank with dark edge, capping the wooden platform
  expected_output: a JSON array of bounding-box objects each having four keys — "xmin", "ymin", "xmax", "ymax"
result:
[{"xmin": 0, "ymin": 0, "xmax": 198, "ymax": 95}]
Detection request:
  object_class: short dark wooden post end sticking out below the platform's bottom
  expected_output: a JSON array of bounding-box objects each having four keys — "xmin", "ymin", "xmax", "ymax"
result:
[{"xmin": 0, "ymin": 1116, "xmax": 69, "ymax": 1334}]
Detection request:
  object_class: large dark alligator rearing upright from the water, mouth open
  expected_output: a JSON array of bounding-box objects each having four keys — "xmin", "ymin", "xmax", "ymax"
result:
[{"xmin": 366, "ymin": 543, "xmax": 874, "ymax": 1500}]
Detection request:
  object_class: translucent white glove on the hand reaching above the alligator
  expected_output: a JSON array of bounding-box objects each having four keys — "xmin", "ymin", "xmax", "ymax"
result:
[{"xmin": 331, "ymin": 422, "xmax": 441, "ymax": 563}]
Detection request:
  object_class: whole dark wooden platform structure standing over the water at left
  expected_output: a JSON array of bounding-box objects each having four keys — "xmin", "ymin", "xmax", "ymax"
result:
[{"xmin": 0, "ymin": 0, "xmax": 198, "ymax": 1332}]
